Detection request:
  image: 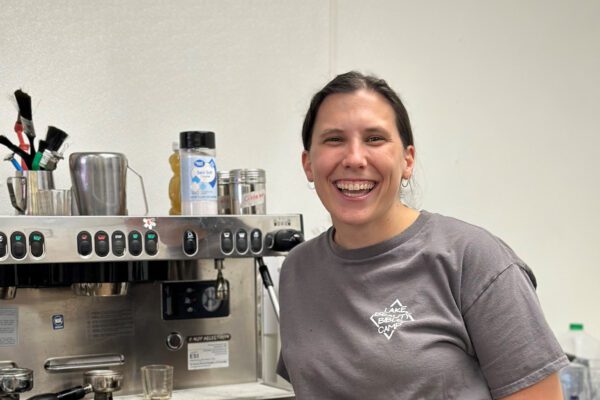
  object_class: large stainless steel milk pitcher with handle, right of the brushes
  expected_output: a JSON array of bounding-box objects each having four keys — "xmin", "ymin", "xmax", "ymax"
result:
[{"xmin": 69, "ymin": 152, "xmax": 148, "ymax": 215}]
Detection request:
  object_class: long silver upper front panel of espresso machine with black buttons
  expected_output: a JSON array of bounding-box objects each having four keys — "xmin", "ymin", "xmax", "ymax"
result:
[{"xmin": 0, "ymin": 214, "xmax": 302, "ymax": 264}]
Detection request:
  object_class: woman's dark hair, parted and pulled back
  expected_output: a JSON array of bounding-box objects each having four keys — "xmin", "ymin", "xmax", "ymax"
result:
[{"xmin": 302, "ymin": 71, "xmax": 414, "ymax": 150}]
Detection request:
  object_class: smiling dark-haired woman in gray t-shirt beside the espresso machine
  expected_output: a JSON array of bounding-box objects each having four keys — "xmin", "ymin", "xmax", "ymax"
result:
[{"xmin": 278, "ymin": 72, "xmax": 568, "ymax": 400}]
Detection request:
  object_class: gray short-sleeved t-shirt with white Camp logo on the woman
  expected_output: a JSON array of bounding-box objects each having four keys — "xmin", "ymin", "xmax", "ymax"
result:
[{"xmin": 278, "ymin": 211, "xmax": 568, "ymax": 400}]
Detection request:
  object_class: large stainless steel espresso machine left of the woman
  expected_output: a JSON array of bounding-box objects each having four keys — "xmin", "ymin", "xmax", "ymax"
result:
[{"xmin": 0, "ymin": 215, "xmax": 303, "ymax": 399}]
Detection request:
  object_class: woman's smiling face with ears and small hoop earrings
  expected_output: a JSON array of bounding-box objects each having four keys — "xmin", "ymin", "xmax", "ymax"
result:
[{"xmin": 302, "ymin": 89, "xmax": 414, "ymax": 228}]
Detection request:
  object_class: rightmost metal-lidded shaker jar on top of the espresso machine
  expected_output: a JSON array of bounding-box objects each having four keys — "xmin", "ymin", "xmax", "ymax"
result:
[{"xmin": 229, "ymin": 169, "xmax": 267, "ymax": 215}]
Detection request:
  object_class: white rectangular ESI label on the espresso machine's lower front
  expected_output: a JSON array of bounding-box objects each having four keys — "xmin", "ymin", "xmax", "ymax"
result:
[{"xmin": 188, "ymin": 334, "xmax": 231, "ymax": 370}]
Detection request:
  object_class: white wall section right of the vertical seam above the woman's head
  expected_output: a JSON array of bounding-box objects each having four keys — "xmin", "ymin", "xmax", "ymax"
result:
[{"xmin": 335, "ymin": 0, "xmax": 600, "ymax": 338}]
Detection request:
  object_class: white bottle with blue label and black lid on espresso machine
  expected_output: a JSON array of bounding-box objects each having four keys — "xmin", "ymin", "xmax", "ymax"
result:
[{"xmin": 179, "ymin": 131, "xmax": 219, "ymax": 215}]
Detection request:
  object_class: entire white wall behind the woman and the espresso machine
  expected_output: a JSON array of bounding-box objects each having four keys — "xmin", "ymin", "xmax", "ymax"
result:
[{"xmin": 0, "ymin": 0, "xmax": 600, "ymax": 337}]
